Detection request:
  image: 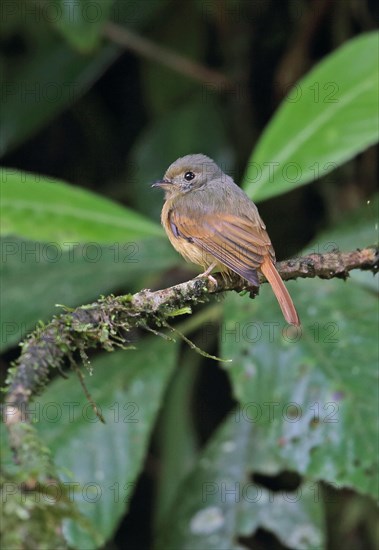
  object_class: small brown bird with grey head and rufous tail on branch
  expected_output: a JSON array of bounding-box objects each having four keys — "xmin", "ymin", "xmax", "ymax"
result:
[{"xmin": 153, "ymin": 155, "xmax": 300, "ymax": 326}]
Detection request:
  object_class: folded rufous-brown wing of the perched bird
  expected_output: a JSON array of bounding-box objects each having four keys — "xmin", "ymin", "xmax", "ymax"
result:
[{"xmin": 170, "ymin": 209, "xmax": 273, "ymax": 284}]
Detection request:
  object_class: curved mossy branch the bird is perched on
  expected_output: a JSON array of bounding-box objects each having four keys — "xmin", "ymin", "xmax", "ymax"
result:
[{"xmin": 5, "ymin": 247, "xmax": 379, "ymax": 438}]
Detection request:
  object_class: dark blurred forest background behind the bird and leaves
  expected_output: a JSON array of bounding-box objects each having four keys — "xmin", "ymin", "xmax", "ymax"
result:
[{"xmin": 0, "ymin": 0, "xmax": 379, "ymax": 550}]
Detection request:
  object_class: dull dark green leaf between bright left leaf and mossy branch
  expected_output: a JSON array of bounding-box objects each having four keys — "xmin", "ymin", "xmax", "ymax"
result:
[{"xmin": 0, "ymin": 238, "xmax": 180, "ymax": 350}]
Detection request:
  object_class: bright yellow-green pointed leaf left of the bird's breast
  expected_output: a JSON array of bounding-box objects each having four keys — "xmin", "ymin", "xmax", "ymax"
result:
[{"xmin": 0, "ymin": 168, "xmax": 162, "ymax": 246}]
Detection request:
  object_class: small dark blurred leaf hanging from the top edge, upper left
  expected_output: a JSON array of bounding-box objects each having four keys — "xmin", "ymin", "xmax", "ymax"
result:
[{"xmin": 48, "ymin": 0, "xmax": 113, "ymax": 53}]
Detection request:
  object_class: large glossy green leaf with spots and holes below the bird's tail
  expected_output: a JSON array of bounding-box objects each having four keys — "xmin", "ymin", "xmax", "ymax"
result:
[{"xmin": 221, "ymin": 199, "xmax": 379, "ymax": 497}]
